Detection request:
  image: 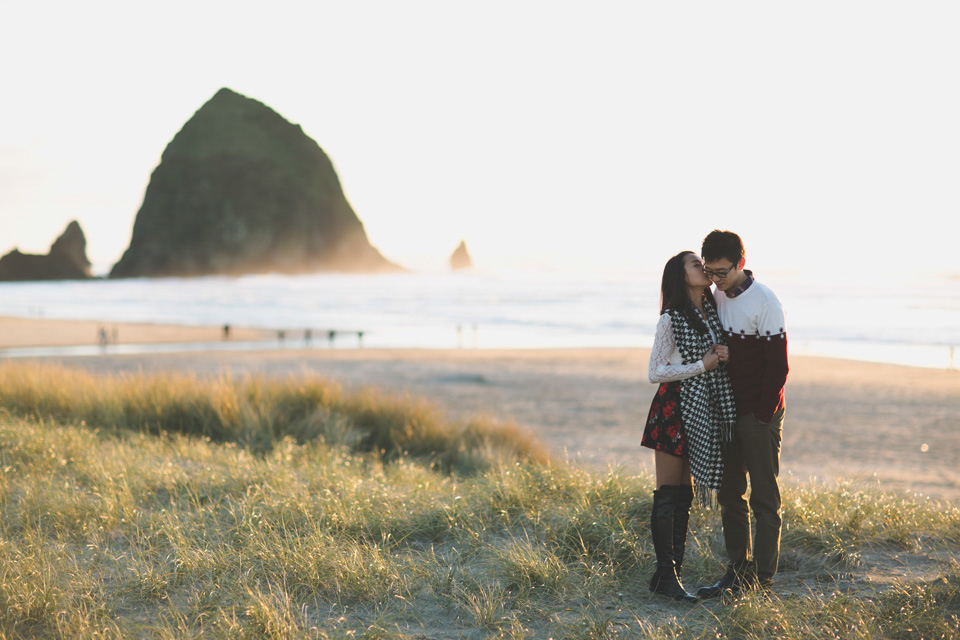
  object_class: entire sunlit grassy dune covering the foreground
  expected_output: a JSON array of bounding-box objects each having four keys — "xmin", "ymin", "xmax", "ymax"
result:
[{"xmin": 0, "ymin": 365, "xmax": 960, "ymax": 639}]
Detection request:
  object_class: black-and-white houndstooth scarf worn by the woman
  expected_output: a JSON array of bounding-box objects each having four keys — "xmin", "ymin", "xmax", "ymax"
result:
[{"xmin": 667, "ymin": 309, "xmax": 737, "ymax": 505}]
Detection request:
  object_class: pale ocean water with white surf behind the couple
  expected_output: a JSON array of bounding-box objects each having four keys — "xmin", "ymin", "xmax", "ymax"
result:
[{"xmin": 0, "ymin": 271, "xmax": 960, "ymax": 369}]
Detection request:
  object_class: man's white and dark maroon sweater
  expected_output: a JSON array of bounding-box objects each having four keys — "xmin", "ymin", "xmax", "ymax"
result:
[{"xmin": 714, "ymin": 272, "xmax": 789, "ymax": 422}]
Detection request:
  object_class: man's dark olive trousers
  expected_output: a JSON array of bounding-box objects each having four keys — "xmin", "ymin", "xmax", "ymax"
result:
[{"xmin": 717, "ymin": 409, "xmax": 783, "ymax": 580}]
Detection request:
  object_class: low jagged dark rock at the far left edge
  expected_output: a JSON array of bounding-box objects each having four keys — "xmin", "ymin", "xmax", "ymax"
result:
[{"xmin": 0, "ymin": 220, "xmax": 91, "ymax": 281}]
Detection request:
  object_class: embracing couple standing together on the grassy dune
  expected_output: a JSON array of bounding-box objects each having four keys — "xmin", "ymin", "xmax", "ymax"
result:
[{"xmin": 641, "ymin": 230, "xmax": 788, "ymax": 602}]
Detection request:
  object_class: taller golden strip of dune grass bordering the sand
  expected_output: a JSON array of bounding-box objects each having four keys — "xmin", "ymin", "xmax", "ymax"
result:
[{"xmin": 0, "ymin": 364, "xmax": 546, "ymax": 472}]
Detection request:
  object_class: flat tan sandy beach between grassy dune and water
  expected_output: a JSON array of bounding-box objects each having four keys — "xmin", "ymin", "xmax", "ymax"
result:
[{"xmin": 0, "ymin": 318, "xmax": 960, "ymax": 501}]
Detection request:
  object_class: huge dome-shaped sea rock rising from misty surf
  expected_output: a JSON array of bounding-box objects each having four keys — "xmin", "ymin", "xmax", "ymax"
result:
[{"xmin": 110, "ymin": 89, "xmax": 401, "ymax": 278}]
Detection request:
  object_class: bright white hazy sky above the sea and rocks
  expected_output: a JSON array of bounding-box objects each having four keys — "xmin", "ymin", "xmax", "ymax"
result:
[{"xmin": 0, "ymin": 0, "xmax": 960, "ymax": 279}]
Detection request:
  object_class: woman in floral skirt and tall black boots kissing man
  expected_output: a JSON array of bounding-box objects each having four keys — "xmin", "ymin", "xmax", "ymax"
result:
[{"xmin": 640, "ymin": 251, "xmax": 737, "ymax": 602}]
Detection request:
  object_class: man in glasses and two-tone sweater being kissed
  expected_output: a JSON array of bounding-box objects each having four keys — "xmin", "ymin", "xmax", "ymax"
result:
[{"xmin": 697, "ymin": 230, "xmax": 788, "ymax": 598}]
